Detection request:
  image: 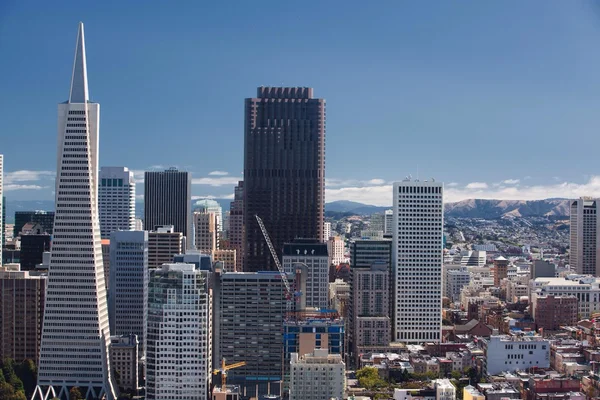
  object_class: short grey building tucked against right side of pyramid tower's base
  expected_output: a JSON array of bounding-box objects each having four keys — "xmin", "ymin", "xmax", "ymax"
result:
[{"xmin": 110, "ymin": 334, "xmax": 140, "ymax": 394}]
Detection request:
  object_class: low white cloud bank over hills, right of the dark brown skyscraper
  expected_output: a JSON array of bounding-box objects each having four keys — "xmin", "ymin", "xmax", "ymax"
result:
[{"xmin": 325, "ymin": 176, "xmax": 600, "ymax": 206}]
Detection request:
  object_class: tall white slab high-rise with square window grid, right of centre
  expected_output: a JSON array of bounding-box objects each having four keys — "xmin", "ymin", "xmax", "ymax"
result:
[{"xmin": 392, "ymin": 180, "xmax": 444, "ymax": 343}]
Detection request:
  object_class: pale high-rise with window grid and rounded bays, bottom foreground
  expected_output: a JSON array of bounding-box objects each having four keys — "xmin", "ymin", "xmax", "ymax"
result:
[{"xmin": 146, "ymin": 264, "xmax": 212, "ymax": 400}]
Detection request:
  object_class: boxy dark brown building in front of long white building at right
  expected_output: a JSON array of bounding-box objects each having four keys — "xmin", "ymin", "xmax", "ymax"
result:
[{"xmin": 532, "ymin": 295, "xmax": 579, "ymax": 331}]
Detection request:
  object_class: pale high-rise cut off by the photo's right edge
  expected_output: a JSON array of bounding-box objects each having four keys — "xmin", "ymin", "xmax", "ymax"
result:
[{"xmin": 569, "ymin": 197, "xmax": 600, "ymax": 276}]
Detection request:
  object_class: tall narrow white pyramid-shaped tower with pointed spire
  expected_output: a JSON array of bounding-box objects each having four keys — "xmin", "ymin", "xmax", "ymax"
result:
[{"xmin": 33, "ymin": 23, "xmax": 116, "ymax": 400}]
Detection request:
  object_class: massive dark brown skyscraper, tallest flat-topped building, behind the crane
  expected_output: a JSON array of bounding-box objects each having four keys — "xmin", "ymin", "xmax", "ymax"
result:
[{"xmin": 244, "ymin": 87, "xmax": 325, "ymax": 272}]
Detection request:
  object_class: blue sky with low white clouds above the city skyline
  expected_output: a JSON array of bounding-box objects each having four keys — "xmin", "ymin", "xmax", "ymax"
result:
[{"xmin": 0, "ymin": 0, "xmax": 600, "ymax": 205}]
